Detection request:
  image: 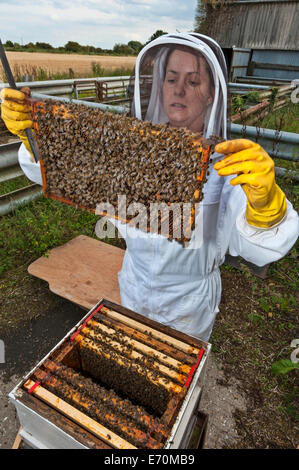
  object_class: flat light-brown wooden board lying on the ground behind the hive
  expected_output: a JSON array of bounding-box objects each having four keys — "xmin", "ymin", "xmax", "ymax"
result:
[{"xmin": 28, "ymin": 235, "xmax": 125, "ymax": 310}]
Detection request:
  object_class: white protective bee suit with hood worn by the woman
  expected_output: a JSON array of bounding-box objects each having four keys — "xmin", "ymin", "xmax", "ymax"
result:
[{"xmin": 19, "ymin": 33, "xmax": 299, "ymax": 341}]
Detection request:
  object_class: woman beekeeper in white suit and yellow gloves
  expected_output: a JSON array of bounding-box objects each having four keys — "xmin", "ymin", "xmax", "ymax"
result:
[{"xmin": 1, "ymin": 33, "xmax": 299, "ymax": 340}]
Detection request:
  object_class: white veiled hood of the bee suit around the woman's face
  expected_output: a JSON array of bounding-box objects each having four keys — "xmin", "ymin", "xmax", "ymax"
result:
[{"xmin": 129, "ymin": 33, "xmax": 227, "ymax": 139}]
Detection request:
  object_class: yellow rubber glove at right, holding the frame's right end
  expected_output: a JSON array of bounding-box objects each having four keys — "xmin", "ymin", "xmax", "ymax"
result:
[{"xmin": 214, "ymin": 139, "xmax": 286, "ymax": 228}]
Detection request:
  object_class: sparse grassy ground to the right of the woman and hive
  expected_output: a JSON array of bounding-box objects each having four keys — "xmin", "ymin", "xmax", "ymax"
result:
[{"xmin": 211, "ymin": 171, "xmax": 299, "ymax": 442}]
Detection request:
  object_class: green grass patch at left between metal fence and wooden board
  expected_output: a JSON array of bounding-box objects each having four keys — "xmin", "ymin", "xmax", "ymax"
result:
[{"xmin": 0, "ymin": 198, "xmax": 98, "ymax": 274}]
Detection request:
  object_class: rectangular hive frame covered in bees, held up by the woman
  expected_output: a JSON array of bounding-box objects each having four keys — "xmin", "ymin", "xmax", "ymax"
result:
[{"xmin": 33, "ymin": 100, "xmax": 219, "ymax": 244}]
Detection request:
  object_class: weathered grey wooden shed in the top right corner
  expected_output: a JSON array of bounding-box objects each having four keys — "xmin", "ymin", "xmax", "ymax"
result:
[{"xmin": 196, "ymin": 0, "xmax": 299, "ymax": 80}]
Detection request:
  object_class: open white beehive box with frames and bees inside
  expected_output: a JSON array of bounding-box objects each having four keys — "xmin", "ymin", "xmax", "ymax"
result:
[{"xmin": 10, "ymin": 299, "xmax": 210, "ymax": 449}]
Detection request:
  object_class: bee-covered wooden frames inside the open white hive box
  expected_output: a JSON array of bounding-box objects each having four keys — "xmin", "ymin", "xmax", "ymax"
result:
[{"xmin": 19, "ymin": 300, "xmax": 205, "ymax": 449}]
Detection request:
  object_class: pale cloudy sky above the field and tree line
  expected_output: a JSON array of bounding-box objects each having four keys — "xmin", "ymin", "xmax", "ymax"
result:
[{"xmin": 0, "ymin": 0, "xmax": 197, "ymax": 49}]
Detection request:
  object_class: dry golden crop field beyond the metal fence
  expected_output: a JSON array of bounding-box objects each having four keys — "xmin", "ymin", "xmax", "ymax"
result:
[{"xmin": 0, "ymin": 51, "xmax": 136, "ymax": 77}]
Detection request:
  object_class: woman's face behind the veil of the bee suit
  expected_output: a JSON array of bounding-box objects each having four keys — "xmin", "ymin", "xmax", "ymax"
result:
[{"xmin": 163, "ymin": 49, "xmax": 213, "ymax": 132}]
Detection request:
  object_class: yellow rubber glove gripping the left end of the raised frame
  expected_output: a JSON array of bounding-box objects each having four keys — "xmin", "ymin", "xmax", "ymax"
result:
[{"xmin": 0, "ymin": 87, "xmax": 34, "ymax": 161}]
